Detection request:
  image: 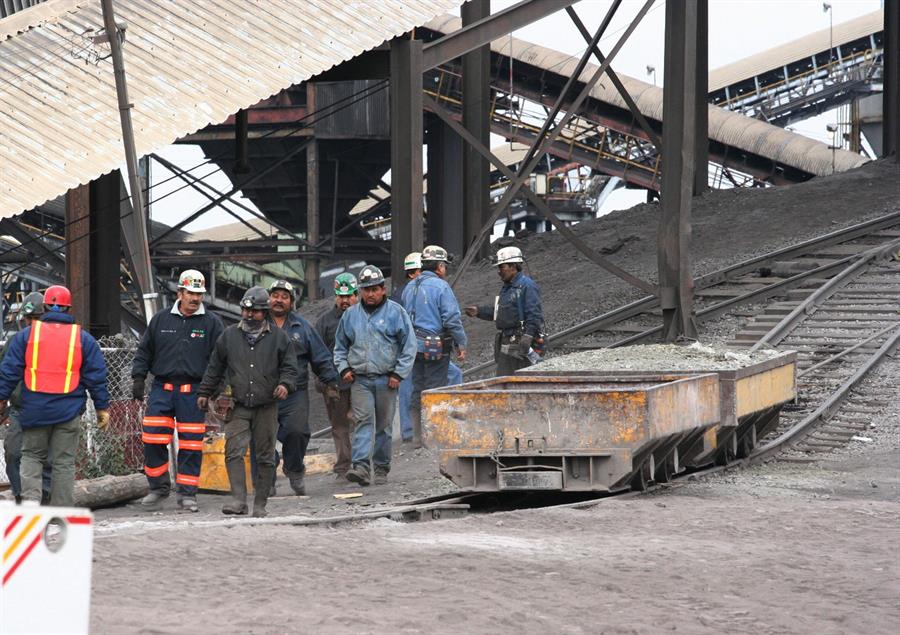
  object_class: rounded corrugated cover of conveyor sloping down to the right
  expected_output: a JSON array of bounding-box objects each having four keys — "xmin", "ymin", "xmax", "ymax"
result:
[{"xmin": 425, "ymin": 15, "xmax": 867, "ymax": 176}]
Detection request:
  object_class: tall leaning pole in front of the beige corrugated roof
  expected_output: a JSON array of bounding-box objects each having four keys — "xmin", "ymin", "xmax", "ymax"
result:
[{"xmin": 100, "ymin": 0, "xmax": 160, "ymax": 322}]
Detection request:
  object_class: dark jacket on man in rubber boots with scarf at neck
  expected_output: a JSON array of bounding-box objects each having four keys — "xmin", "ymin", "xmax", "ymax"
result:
[{"xmin": 197, "ymin": 324, "xmax": 300, "ymax": 408}]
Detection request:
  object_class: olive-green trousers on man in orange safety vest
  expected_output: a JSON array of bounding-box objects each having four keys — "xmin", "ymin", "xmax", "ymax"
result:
[{"xmin": 21, "ymin": 415, "xmax": 81, "ymax": 507}]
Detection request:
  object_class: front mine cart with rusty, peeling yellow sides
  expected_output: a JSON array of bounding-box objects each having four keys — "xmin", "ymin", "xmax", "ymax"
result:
[{"xmin": 422, "ymin": 374, "xmax": 721, "ymax": 492}]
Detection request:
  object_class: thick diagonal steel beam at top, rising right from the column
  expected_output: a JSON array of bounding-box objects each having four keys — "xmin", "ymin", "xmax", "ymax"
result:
[{"xmin": 422, "ymin": 0, "xmax": 578, "ymax": 70}]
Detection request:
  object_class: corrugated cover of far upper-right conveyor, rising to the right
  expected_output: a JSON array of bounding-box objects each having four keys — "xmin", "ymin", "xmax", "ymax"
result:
[{"xmin": 709, "ymin": 9, "xmax": 884, "ymax": 92}]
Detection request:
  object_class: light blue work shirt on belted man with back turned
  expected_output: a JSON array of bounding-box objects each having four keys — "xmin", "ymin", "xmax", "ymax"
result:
[{"xmin": 403, "ymin": 271, "xmax": 468, "ymax": 352}]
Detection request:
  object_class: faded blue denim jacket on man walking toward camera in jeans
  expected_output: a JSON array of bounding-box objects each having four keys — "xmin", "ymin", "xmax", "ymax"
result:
[{"xmin": 334, "ymin": 298, "xmax": 416, "ymax": 379}]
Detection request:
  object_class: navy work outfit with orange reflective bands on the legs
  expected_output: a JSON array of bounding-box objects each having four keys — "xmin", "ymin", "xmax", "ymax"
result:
[{"xmin": 131, "ymin": 302, "xmax": 224, "ymax": 496}]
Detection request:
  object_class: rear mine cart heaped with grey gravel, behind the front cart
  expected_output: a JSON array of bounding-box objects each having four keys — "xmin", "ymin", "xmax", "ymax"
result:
[{"xmin": 517, "ymin": 346, "xmax": 797, "ymax": 474}]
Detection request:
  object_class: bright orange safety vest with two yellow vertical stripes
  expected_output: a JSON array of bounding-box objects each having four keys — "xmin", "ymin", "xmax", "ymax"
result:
[{"xmin": 25, "ymin": 321, "xmax": 81, "ymax": 395}]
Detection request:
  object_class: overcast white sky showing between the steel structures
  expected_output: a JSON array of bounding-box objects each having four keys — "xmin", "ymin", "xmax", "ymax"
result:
[{"xmin": 151, "ymin": 0, "xmax": 881, "ymax": 231}]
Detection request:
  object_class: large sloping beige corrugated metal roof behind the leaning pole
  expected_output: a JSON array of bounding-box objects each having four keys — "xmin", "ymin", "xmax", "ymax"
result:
[{"xmin": 0, "ymin": 0, "xmax": 462, "ymax": 217}]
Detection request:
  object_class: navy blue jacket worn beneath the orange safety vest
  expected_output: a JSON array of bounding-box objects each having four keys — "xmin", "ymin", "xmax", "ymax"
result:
[{"xmin": 0, "ymin": 311, "xmax": 109, "ymax": 428}]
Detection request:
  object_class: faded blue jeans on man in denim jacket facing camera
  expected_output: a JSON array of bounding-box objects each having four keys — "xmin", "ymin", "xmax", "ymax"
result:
[{"xmin": 350, "ymin": 375, "xmax": 397, "ymax": 471}]
